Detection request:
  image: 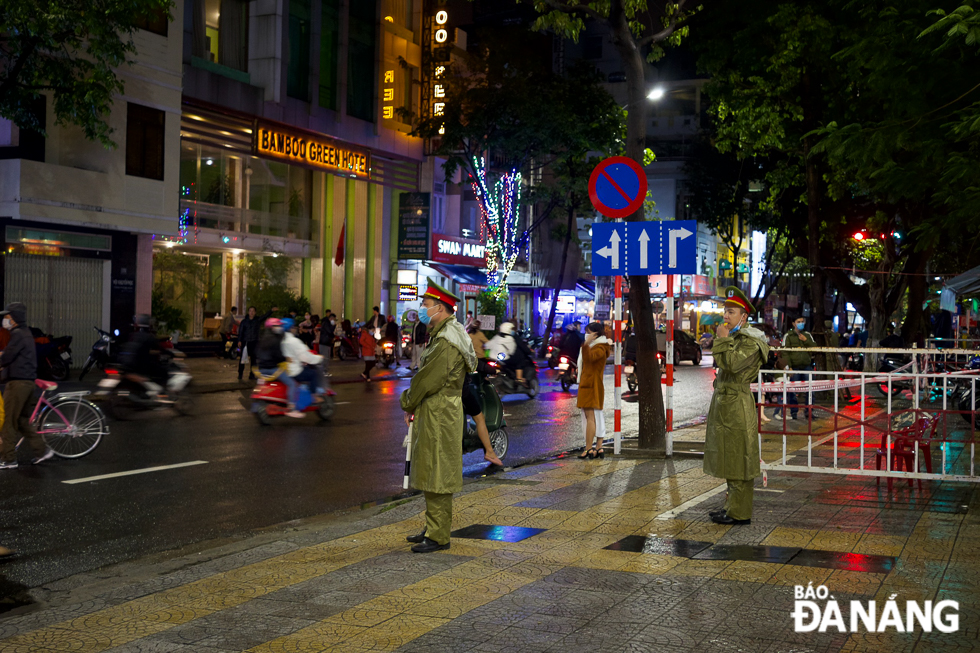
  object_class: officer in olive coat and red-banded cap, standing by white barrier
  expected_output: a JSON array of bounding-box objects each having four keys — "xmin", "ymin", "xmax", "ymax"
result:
[{"xmin": 704, "ymin": 286, "xmax": 769, "ymax": 525}]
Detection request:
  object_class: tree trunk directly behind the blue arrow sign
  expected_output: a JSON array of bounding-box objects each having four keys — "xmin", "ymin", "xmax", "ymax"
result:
[{"xmin": 609, "ymin": 0, "xmax": 667, "ymax": 455}]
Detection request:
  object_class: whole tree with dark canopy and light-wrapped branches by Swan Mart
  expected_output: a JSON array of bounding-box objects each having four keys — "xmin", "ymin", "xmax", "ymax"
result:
[{"xmin": 413, "ymin": 29, "xmax": 621, "ymax": 297}]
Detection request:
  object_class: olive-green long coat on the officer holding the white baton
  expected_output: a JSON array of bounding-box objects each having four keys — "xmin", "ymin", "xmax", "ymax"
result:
[{"xmin": 401, "ymin": 317, "xmax": 476, "ymax": 494}]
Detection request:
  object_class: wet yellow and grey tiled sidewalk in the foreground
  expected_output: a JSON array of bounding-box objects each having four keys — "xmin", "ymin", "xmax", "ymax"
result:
[{"xmin": 0, "ymin": 448, "xmax": 980, "ymax": 653}]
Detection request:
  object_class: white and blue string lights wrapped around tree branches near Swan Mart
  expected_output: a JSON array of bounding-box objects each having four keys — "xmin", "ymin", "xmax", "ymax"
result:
[{"xmin": 472, "ymin": 157, "xmax": 529, "ymax": 297}]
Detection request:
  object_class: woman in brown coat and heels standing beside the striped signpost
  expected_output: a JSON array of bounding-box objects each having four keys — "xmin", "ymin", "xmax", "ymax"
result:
[{"xmin": 575, "ymin": 322, "xmax": 612, "ymax": 460}]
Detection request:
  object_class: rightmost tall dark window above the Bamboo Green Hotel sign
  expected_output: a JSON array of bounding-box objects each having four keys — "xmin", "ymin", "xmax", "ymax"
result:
[{"xmin": 347, "ymin": 2, "xmax": 378, "ymax": 122}]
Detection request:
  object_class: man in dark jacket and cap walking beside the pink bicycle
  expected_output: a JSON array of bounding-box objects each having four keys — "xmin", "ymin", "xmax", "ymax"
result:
[{"xmin": 0, "ymin": 302, "xmax": 54, "ymax": 469}]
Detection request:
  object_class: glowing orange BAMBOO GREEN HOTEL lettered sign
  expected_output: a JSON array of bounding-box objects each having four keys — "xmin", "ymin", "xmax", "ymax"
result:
[{"xmin": 252, "ymin": 122, "xmax": 371, "ymax": 179}]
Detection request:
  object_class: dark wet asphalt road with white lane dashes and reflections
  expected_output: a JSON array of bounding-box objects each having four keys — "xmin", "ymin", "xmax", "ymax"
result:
[{"xmin": 0, "ymin": 358, "xmax": 713, "ymax": 587}]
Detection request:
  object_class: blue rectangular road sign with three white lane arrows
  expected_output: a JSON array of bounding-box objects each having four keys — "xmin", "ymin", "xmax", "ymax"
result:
[{"xmin": 592, "ymin": 220, "xmax": 698, "ymax": 277}]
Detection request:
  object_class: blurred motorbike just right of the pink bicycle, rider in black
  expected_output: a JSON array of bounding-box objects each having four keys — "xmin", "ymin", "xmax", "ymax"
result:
[{"xmin": 95, "ymin": 352, "xmax": 197, "ymax": 420}]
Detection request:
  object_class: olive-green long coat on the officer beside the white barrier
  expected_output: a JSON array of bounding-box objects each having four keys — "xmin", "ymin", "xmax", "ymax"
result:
[{"xmin": 704, "ymin": 326, "xmax": 769, "ymax": 481}]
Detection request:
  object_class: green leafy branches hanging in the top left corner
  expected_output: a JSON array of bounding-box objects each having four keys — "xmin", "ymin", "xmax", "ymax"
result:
[{"xmin": 0, "ymin": 0, "xmax": 172, "ymax": 148}]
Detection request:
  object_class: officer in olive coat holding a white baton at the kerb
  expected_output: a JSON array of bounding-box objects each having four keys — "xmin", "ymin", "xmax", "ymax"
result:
[{"xmin": 401, "ymin": 283, "xmax": 476, "ymax": 553}]
